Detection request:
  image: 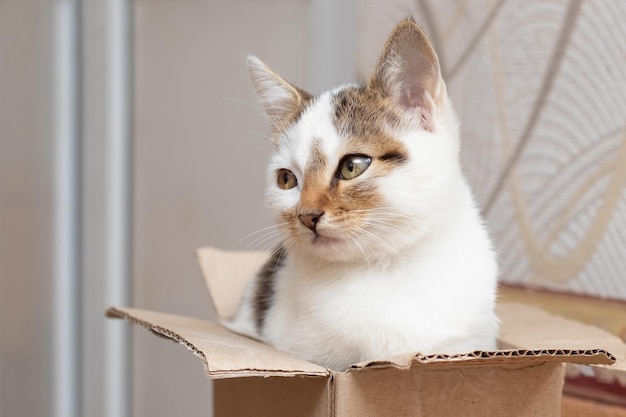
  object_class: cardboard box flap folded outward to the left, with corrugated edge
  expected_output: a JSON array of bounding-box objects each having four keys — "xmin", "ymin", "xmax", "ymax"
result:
[{"xmin": 107, "ymin": 308, "xmax": 329, "ymax": 378}]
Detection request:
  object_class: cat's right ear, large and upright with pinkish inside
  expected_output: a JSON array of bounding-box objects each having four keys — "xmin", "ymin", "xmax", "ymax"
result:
[{"xmin": 370, "ymin": 19, "xmax": 446, "ymax": 131}]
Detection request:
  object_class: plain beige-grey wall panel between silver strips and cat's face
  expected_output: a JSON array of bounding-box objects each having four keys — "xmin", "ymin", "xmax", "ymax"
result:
[{"xmin": 133, "ymin": 0, "xmax": 309, "ymax": 416}]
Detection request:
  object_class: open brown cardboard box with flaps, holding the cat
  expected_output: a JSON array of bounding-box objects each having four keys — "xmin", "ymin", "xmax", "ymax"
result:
[{"xmin": 107, "ymin": 248, "xmax": 626, "ymax": 417}]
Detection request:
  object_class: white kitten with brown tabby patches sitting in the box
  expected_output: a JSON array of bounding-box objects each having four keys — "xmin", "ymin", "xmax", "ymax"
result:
[{"xmin": 225, "ymin": 19, "xmax": 499, "ymax": 371}]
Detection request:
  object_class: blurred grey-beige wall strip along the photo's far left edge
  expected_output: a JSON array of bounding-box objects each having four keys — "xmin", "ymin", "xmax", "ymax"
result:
[{"xmin": 0, "ymin": 0, "xmax": 54, "ymax": 417}]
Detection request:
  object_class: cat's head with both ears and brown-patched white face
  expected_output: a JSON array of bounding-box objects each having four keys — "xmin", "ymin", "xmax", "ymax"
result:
[{"xmin": 248, "ymin": 20, "xmax": 461, "ymax": 262}]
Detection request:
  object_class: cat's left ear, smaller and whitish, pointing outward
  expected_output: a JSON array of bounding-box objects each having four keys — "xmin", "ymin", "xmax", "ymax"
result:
[{"xmin": 248, "ymin": 55, "xmax": 311, "ymax": 136}]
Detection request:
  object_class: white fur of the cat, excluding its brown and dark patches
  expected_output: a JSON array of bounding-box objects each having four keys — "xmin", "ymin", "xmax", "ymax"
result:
[{"xmin": 228, "ymin": 92, "xmax": 498, "ymax": 370}]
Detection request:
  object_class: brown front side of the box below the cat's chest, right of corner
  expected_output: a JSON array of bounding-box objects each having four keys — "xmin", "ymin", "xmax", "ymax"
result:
[{"xmin": 335, "ymin": 363, "xmax": 563, "ymax": 417}]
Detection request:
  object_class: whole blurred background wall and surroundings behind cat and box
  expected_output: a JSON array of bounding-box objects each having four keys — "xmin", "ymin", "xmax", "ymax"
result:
[{"xmin": 0, "ymin": 0, "xmax": 626, "ymax": 417}]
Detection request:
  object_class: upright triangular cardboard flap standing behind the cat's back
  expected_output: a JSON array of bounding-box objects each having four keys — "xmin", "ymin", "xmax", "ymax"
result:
[{"xmin": 196, "ymin": 247, "xmax": 269, "ymax": 319}]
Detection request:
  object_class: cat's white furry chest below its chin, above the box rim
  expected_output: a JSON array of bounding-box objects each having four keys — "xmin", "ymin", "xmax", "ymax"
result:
[{"xmin": 258, "ymin": 247, "xmax": 490, "ymax": 364}]
